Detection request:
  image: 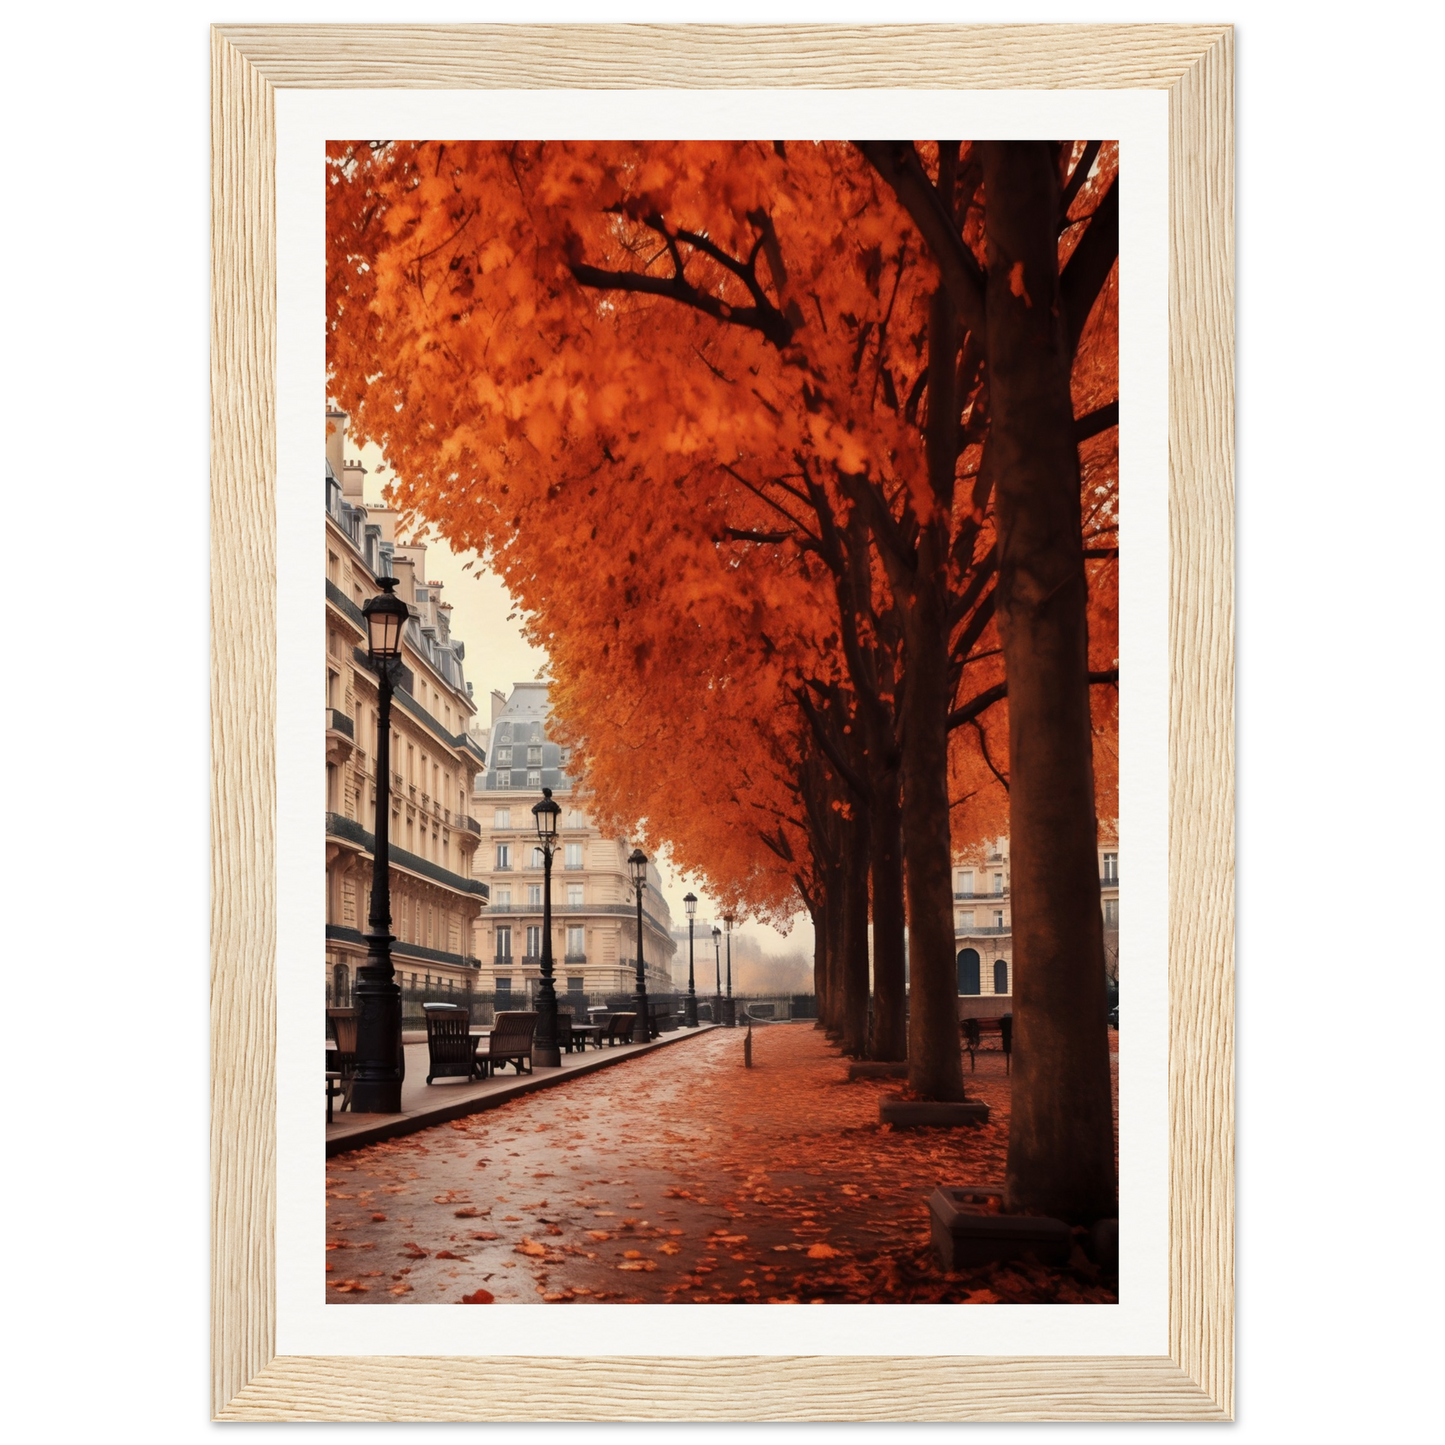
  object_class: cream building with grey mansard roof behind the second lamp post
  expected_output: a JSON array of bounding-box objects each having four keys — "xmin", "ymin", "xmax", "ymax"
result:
[{"xmin": 473, "ymin": 682, "xmax": 686, "ymax": 1007}]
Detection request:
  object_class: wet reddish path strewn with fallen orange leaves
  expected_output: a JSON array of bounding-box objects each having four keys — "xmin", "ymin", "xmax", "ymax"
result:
[{"xmin": 325, "ymin": 1025, "xmax": 1117, "ymax": 1303}]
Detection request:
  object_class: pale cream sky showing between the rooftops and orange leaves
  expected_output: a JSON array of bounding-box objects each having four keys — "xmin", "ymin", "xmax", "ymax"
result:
[{"xmin": 356, "ymin": 438, "xmax": 814, "ymax": 958}]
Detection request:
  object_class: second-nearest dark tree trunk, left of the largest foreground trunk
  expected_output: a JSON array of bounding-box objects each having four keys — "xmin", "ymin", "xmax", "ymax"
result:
[{"xmin": 903, "ymin": 569, "xmax": 964, "ymax": 1100}]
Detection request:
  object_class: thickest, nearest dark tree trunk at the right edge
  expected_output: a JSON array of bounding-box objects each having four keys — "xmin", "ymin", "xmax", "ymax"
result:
[{"xmin": 981, "ymin": 142, "xmax": 1118, "ymax": 1222}]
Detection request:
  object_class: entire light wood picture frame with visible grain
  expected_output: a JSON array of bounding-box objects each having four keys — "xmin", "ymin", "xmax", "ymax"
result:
[{"xmin": 202, "ymin": 20, "xmax": 1243, "ymax": 1435}]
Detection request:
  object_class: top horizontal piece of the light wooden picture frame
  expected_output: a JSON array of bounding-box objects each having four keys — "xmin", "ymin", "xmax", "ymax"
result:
[{"xmin": 218, "ymin": 22, "xmax": 1227, "ymax": 90}]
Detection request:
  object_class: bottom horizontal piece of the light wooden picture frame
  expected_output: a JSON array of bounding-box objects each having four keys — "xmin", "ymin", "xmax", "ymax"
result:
[{"xmin": 218, "ymin": 1355, "xmax": 1224, "ymax": 1420}]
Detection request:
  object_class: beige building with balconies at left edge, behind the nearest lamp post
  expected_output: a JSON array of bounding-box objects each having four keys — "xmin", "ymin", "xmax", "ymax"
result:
[{"xmin": 325, "ymin": 410, "xmax": 487, "ymax": 1006}]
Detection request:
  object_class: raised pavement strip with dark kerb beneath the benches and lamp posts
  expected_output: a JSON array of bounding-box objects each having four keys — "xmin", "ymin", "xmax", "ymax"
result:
[{"xmin": 327, "ymin": 1023, "xmax": 718, "ymax": 1159}]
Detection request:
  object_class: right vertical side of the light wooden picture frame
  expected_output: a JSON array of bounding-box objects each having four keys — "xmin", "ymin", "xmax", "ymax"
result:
[{"xmin": 1169, "ymin": 32, "xmax": 1234, "ymax": 1412}]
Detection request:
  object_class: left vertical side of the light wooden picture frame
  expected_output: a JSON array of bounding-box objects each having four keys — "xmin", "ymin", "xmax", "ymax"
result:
[{"xmin": 210, "ymin": 25, "xmax": 276, "ymax": 1405}]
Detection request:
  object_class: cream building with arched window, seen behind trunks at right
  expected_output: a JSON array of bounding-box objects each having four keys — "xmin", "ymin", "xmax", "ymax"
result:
[{"xmin": 954, "ymin": 838, "xmax": 1118, "ymax": 997}]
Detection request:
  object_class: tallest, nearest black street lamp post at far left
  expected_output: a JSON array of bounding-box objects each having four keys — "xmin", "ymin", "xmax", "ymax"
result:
[{"xmin": 351, "ymin": 577, "xmax": 410, "ymax": 1114}]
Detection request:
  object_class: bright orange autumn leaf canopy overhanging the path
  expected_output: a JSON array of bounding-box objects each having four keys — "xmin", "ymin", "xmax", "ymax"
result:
[{"xmin": 327, "ymin": 142, "xmax": 1117, "ymax": 901}]
